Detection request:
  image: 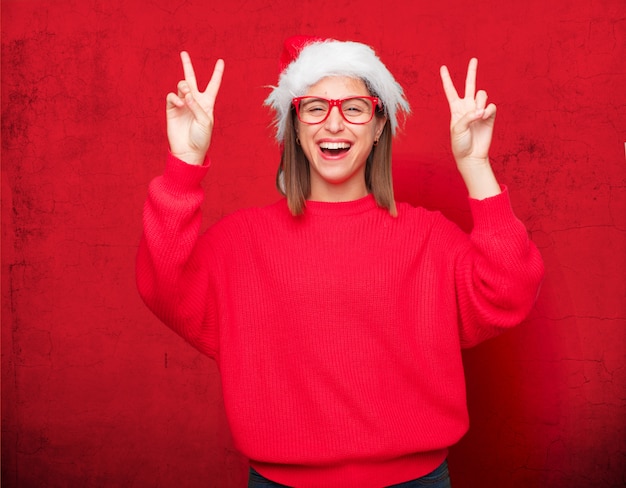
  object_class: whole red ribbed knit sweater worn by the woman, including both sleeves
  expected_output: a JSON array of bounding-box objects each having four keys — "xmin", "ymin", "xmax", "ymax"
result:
[{"xmin": 137, "ymin": 156, "xmax": 543, "ymax": 487}]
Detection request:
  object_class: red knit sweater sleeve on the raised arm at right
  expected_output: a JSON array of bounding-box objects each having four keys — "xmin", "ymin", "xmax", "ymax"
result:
[{"xmin": 455, "ymin": 187, "xmax": 544, "ymax": 347}]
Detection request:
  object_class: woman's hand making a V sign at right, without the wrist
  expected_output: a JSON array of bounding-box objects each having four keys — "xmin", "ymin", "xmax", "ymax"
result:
[{"xmin": 440, "ymin": 58, "xmax": 496, "ymax": 171}]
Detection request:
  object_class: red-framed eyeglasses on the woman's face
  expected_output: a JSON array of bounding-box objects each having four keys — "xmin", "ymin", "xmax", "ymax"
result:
[{"xmin": 292, "ymin": 97, "xmax": 379, "ymax": 125}]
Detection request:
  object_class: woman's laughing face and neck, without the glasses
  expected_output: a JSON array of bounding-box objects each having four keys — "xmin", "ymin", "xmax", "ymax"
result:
[{"xmin": 296, "ymin": 76, "xmax": 386, "ymax": 202}]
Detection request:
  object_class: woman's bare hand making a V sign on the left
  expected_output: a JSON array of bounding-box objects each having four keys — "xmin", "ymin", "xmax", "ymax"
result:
[{"xmin": 166, "ymin": 51, "xmax": 224, "ymax": 166}]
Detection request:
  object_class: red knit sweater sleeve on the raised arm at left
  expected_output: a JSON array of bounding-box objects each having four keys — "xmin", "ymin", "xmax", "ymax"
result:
[{"xmin": 136, "ymin": 154, "xmax": 217, "ymax": 357}]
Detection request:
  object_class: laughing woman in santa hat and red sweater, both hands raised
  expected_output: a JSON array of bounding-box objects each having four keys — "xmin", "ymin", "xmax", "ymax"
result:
[{"xmin": 137, "ymin": 37, "xmax": 543, "ymax": 487}]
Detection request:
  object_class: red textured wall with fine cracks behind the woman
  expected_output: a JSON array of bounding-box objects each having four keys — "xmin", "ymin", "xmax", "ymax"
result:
[{"xmin": 2, "ymin": 0, "xmax": 626, "ymax": 488}]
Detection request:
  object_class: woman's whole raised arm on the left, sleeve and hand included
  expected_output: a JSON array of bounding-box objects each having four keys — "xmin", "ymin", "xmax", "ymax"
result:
[{"xmin": 136, "ymin": 52, "xmax": 224, "ymax": 355}]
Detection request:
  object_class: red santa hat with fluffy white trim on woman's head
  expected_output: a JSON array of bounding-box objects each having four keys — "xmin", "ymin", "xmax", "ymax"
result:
[{"xmin": 265, "ymin": 36, "xmax": 410, "ymax": 143}]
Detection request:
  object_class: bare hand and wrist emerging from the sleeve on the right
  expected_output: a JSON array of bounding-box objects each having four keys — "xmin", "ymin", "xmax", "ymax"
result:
[{"xmin": 440, "ymin": 58, "xmax": 500, "ymax": 200}]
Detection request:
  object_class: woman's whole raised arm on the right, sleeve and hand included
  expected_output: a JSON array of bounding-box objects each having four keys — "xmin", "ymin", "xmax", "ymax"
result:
[{"xmin": 441, "ymin": 58, "xmax": 544, "ymax": 347}]
